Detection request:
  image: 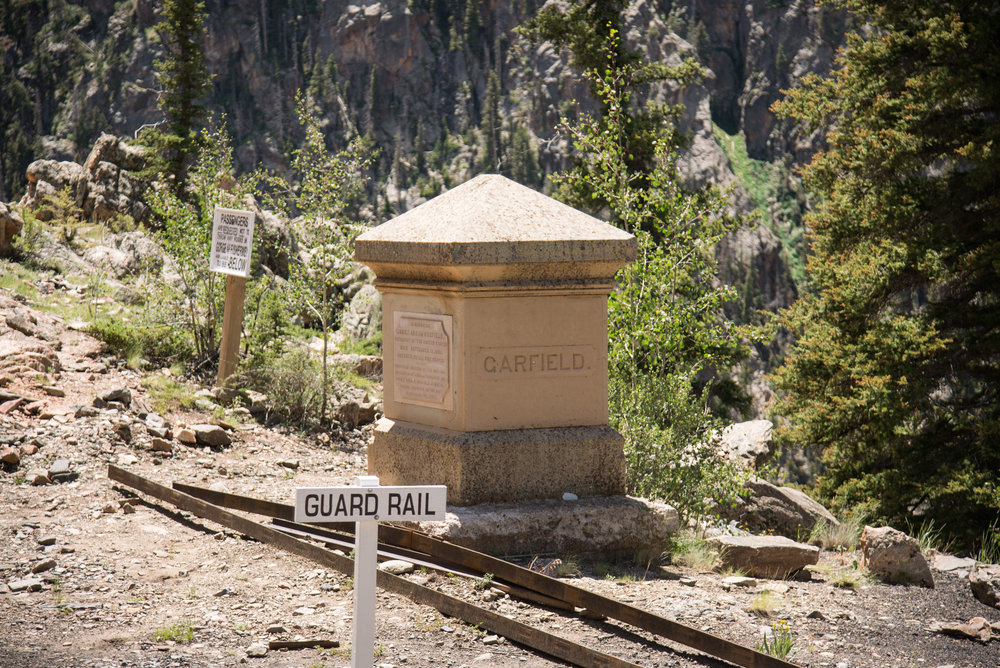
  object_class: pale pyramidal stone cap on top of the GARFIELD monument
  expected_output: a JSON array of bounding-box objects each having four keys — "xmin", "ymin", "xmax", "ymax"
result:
[{"xmin": 354, "ymin": 174, "xmax": 636, "ymax": 280}]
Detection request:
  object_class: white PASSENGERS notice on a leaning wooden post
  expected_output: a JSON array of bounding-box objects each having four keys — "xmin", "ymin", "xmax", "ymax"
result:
[{"xmin": 209, "ymin": 206, "xmax": 254, "ymax": 387}]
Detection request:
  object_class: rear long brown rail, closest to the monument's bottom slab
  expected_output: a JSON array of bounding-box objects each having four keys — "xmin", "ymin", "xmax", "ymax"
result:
[{"xmin": 174, "ymin": 483, "xmax": 795, "ymax": 668}]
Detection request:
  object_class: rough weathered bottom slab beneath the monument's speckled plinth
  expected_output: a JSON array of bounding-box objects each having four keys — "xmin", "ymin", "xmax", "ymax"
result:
[{"xmin": 406, "ymin": 496, "xmax": 679, "ymax": 562}]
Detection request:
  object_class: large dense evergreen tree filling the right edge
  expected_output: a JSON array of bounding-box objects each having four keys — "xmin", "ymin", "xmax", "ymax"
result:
[{"xmin": 776, "ymin": 0, "xmax": 1000, "ymax": 545}]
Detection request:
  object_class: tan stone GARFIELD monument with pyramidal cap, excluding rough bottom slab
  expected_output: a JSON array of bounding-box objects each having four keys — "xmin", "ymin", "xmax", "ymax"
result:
[{"xmin": 355, "ymin": 175, "xmax": 676, "ymax": 552}]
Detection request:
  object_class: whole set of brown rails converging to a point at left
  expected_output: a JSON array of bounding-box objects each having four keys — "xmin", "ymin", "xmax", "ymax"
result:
[{"xmin": 108, "ymin": 465, "xmax": 794, "ymax": 668}]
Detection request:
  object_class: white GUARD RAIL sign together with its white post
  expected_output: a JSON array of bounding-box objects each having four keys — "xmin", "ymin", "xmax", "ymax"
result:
[{"xmin": 295, "ymin": 475, "xmax": 448, "ymax": 668}]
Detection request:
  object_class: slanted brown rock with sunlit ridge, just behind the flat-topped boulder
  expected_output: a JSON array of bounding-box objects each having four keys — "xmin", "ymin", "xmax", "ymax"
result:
[{"xmin": 719, "ymin": 478, "xmax": 840, "ymax": 538}]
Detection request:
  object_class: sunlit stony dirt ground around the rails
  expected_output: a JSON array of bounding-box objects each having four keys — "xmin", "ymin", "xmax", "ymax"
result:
[{"xmin": 0, "ymin": 295, "xmax": 1000, "ymax": 668}]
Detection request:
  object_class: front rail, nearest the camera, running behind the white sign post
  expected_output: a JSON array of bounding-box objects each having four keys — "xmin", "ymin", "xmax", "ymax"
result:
[{"xmin": 108, "ymin": 465, "xmax": 640, "ymax": 668}]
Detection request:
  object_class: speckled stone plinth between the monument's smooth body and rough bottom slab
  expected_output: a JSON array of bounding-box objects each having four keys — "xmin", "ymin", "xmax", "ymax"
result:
[{"xmin": 368, "ymin": 418, "xmax": 625, "ymax": 506}]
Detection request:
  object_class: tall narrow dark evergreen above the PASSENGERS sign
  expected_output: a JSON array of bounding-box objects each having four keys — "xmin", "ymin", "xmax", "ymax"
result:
[{"xmin": 149, "ymin": 0, "xmax": 211, "ymax": 193}]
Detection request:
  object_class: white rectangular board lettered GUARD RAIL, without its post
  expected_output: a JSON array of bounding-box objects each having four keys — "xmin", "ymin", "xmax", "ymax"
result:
[{"xmin": 295, "ymin": 485, "xmax": 448, "ymax": 523}]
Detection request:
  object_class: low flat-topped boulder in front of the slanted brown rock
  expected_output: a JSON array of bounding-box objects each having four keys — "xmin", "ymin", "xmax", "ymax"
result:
[{"xmin": 708, "ymin": 536, "xmax": 819, "ymax": 579}]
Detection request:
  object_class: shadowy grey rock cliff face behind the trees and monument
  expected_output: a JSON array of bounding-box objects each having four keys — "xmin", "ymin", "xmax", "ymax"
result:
[{"xmin": 0, "ymin": 0, "xmax": 845, "ymax": 344}]
